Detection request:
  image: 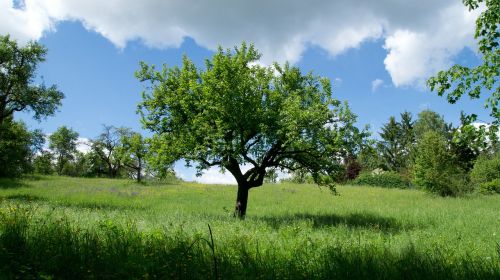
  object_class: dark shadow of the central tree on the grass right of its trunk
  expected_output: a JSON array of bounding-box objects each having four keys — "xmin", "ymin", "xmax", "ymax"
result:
[{"xmin": 257, "ymin": 212, "xmax": 423, "ymax": 234}]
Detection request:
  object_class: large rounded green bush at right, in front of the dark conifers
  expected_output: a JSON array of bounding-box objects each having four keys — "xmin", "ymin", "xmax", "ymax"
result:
[{"xmin": 413, "ymin": 130, "xmax": 470, "ymax": 196}]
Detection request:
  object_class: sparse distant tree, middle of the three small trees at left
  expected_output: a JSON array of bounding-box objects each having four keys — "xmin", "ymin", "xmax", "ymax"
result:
[{"xmin": 91, "ymin": 125, "xmax": 130, "ymax": 178}]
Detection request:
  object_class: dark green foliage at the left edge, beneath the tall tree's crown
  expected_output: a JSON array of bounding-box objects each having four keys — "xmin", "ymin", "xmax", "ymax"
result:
[{"xmin": 0, "ymin": 120, "xmax": 32, "ymax": 177}]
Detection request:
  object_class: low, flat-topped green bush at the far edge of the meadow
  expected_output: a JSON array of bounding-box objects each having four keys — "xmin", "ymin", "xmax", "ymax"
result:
[{"xmin": 352, "ymin": 171, "xmax": 410, "ymax": 188}]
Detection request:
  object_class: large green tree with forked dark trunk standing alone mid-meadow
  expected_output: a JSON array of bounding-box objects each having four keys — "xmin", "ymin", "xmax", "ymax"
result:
[{"xmin": 136, "ymin": 43, "xmax": 352, "ymax": 218}]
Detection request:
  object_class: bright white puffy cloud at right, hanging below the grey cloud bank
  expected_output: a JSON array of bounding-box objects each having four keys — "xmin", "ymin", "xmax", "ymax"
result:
[{"xmin": 384, "ymin": 2, "xmax": 476, "ymax": 86}]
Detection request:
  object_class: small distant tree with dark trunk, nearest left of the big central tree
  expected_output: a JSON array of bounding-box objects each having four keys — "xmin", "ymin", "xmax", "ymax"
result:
[{"xmin": 118, "ymin": 132, "xmax": 149, "ymax": 182}]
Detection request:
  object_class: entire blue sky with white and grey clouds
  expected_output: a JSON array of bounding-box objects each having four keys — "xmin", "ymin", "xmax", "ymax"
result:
[{"xmin": 0, "ymin": 0, "xmax": 491, "ymax": 183}]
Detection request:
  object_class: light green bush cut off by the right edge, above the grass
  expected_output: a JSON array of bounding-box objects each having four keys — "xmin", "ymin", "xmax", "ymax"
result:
[{"xmin": 470, "ymin": 153, "xmax": 500, "ymax": 187}]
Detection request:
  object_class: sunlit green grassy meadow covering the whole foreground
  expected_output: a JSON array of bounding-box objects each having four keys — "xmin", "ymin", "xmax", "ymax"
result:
[{"xmin": 0, "ymin": 177, "xmax": 500, "ymax": 279}]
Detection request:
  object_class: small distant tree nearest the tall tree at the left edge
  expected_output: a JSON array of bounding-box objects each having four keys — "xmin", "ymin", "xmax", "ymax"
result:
[{"xmin": 49, "ymin": 126, "xmax": 78, "ymax": 175}]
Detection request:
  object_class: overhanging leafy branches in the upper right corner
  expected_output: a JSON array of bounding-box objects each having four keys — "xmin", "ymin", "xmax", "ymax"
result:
[{"xmin": 427, "ymin": 0, "xmax": 500, "ymax": 135}]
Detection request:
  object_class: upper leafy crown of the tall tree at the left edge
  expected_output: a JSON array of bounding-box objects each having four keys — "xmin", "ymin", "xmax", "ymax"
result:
[{"xmin": 0, "ymin": 35, "xmax": 64, "ymax": 126}]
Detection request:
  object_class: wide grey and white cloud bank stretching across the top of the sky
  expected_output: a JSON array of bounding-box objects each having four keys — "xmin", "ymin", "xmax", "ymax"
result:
[{"xmin": 0, "ymin": 0, "xmax": 478, "ymax": 86}]
